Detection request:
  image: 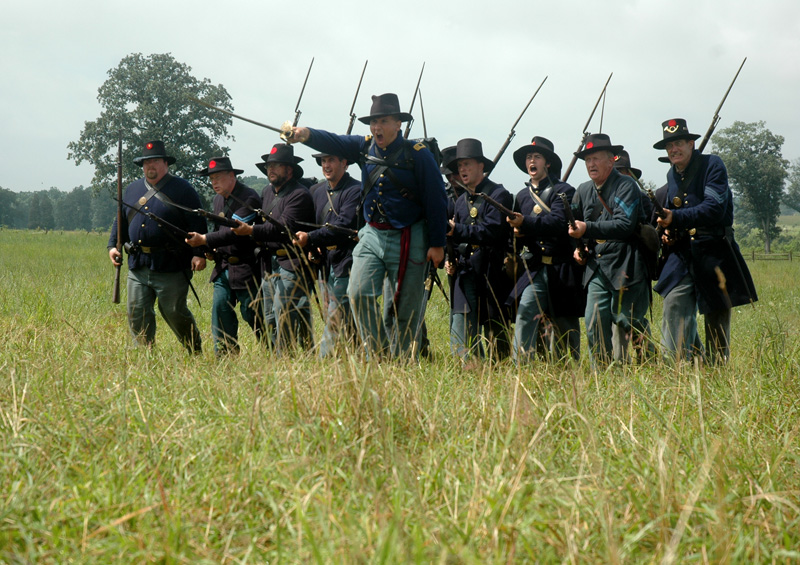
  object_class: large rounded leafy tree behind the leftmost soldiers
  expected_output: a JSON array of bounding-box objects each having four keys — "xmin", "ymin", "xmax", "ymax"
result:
[{"xmin": 67, "ymin": 53, "xmax": 233, "ymax": 202}]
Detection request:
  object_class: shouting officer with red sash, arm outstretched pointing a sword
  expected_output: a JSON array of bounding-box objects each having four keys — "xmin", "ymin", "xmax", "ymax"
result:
[{"xmin": 289, "ymin": 93, "xmax": 447, "ymax": 358}]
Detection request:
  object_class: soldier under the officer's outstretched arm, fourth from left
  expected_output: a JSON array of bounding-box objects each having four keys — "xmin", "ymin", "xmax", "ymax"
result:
[{"xmin": 295, "ymin": 153, "xmax": 361, "ymax": 357}]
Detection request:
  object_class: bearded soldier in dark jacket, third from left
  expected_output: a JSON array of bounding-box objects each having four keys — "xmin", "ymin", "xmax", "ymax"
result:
[{"xmin": 233, "ymin": 143, "xmax": 314, "ymax": 352}]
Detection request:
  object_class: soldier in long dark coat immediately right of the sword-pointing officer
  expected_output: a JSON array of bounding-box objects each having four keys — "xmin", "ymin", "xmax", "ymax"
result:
[{"xmin": 446, "ymin": 138, "xmax": 512, "ymax": 361}]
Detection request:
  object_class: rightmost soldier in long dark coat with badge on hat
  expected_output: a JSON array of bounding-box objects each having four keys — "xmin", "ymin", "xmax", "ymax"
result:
[{"xmin": 653, "ymin": 118, "xmax": 758, "ymax": 363}]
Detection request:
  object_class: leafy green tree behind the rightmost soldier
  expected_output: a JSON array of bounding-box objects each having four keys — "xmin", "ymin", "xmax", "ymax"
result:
[{"xmin": 714, "ymin": 121, "xmax": 789, "ymax": 253}]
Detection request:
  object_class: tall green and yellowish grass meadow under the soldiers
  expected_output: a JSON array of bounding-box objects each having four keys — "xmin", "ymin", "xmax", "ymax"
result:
[{"xmin": 0, "ymin": 230, "xmax": 800, "ymax": 564}]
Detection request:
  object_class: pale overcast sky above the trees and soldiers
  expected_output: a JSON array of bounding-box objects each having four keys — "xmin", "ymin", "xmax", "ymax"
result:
[{"xmin": 0, "ymin": 0, "xmax": 800, "ymax": 192}]
